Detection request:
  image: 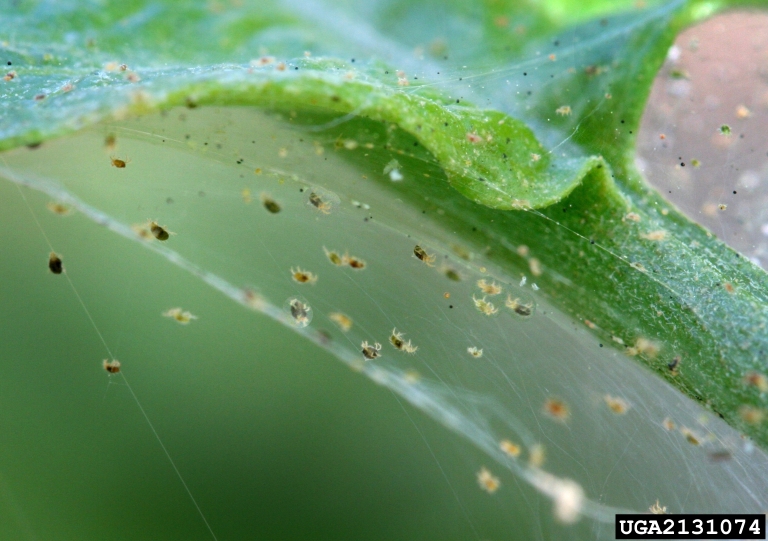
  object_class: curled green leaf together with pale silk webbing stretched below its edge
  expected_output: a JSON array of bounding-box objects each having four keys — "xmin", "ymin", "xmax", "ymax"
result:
[{"xmin": 0, "ymin": 0, "xmax": 768, "ymax": 536}]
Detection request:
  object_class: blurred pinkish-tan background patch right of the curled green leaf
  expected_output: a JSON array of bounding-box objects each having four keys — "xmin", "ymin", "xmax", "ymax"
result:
[{"xmin": 638, "ymin": 12, "xmax": 768, "ymax": 268}]
